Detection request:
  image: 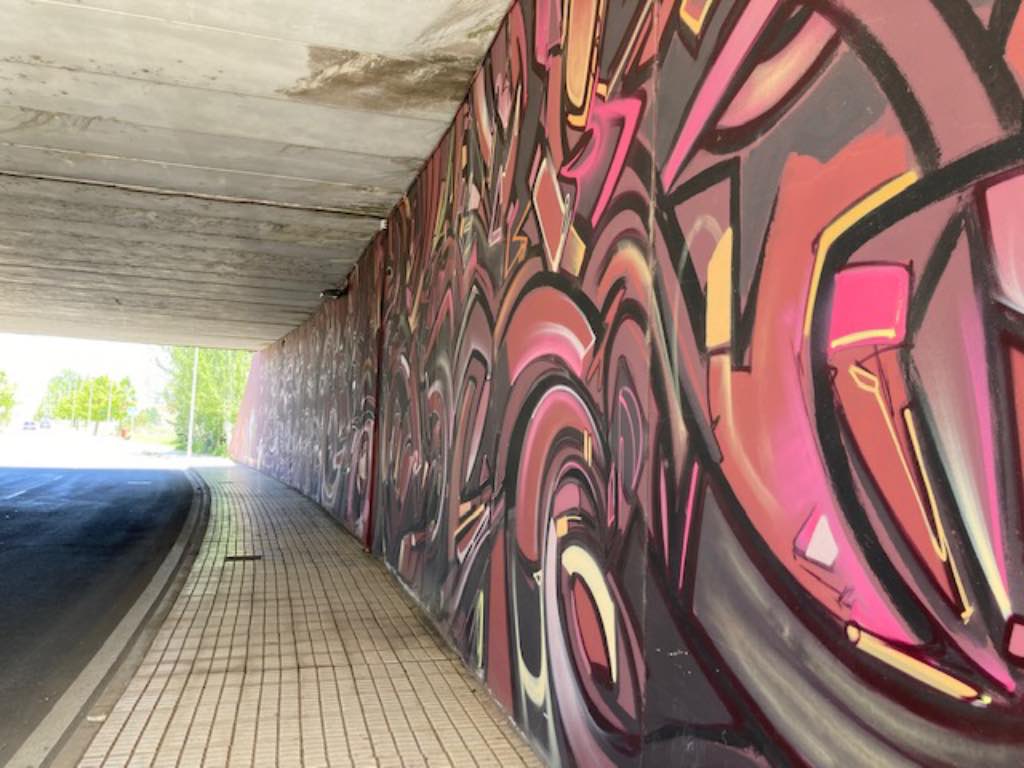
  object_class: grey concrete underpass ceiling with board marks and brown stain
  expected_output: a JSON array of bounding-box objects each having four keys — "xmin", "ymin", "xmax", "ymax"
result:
[{"xmin": 0, "ymin": 0, "xmax": 509, "ymax": 348}]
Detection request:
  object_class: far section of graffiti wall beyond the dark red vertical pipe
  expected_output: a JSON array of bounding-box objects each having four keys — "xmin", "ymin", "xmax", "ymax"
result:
[{"xmin": 231, "ymin": 240, "xmax": 383, "ymax": 539}]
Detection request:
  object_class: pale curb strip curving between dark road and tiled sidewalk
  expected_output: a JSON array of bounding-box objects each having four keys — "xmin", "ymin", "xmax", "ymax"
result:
[{"xmin": 7, "ymin": 469, "xmax": 210, "ymax": 768}]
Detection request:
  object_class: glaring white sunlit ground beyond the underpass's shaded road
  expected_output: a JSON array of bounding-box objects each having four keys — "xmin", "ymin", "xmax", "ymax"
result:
[{"xmin": 0, "ymin": 426, "xmax": 231, "ymax": 469}]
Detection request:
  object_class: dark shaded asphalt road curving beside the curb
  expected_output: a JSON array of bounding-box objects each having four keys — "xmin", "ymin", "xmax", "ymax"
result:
[{"xmin": 0, "ymin": 468, "xmax": 191, "ymax": 765}]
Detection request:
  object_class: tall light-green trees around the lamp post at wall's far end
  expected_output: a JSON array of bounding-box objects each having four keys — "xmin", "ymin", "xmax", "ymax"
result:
[{"xmin": 163, "ymin": 347, "xmax": 252, "ymax": 456}]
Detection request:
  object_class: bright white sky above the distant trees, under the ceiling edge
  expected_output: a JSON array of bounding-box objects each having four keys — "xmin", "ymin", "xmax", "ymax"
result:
[{"xmin": 0, "ymin": 334, "xmax": 167, "ymax": 423}]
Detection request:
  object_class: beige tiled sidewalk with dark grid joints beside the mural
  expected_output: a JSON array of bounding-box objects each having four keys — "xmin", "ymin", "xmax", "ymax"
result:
[{"xmin": 80, "ymin": 467, "xmax": 540, "ymax": 768}]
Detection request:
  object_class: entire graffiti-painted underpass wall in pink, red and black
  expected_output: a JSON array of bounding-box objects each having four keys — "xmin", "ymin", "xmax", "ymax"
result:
[{"xmin": 236, "ymin": 0, "xmax": 1024, "ymax": 766}]
